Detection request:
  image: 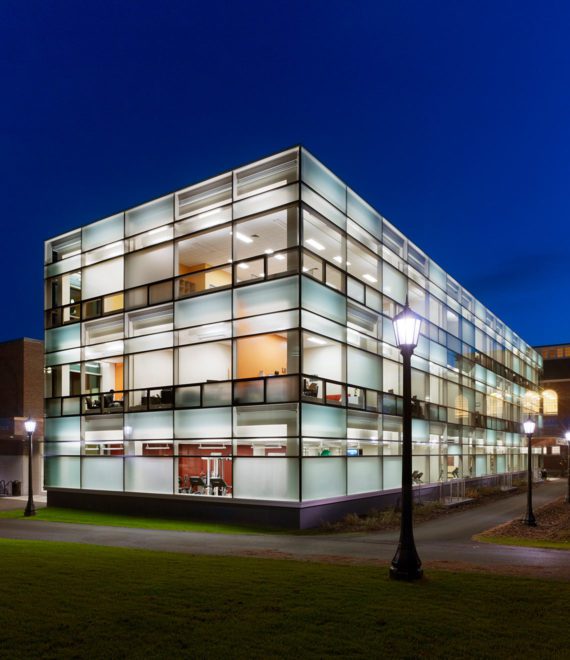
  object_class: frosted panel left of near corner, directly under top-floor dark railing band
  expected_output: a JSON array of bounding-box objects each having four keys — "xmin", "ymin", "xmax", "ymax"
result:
[{"xmin": 234, "ymin": 277, "xmax": 299, "ymax": 317}]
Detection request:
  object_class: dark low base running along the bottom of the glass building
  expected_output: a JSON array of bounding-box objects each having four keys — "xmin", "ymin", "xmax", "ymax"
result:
[{"xmin": 47, "ymin": 472, "xmax": 526, "ymax": 529}]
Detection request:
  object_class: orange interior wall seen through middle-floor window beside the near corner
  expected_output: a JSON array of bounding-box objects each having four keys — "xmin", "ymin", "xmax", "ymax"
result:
[{"xmin": 237, "ymin": 334, "xmax": 287, "ymax": 378}]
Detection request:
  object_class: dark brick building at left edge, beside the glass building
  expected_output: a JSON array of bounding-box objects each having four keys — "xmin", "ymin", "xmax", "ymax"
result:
[{"xmin": 0, "ymin": 338, "xmax": 44, "ymax": 494}]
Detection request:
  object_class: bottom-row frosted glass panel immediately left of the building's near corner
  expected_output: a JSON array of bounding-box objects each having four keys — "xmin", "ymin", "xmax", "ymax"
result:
[{"xmin": 234, "ymin": 458, "xmax": 299, "ymax": 500}]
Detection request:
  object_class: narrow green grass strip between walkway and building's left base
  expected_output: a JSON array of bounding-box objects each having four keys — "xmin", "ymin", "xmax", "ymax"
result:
[{"xmin": 0, "ymin": 507, "xmax": 272, "ymax": 534}]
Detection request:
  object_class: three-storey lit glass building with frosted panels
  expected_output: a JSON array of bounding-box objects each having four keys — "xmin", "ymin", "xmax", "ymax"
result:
[{"xmin": 44, "ymin": 147, "xmax": 541, "ymax": 526}]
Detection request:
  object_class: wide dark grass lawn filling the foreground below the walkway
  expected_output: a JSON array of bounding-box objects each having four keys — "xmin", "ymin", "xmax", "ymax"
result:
[{"xmin": 0, "ymin": 540, "xmax": 570, "ymax": 659}]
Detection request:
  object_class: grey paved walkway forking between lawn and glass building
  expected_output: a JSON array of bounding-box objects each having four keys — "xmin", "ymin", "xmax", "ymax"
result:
[{"xmin": 0, "ymin": 481, "xmax": 570, "ymax": 579}]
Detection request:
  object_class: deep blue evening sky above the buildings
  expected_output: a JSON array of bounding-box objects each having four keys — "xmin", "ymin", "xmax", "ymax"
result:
[{"xmin": 0, "ymin": 0, "xmax": 570, "ymax": 344}]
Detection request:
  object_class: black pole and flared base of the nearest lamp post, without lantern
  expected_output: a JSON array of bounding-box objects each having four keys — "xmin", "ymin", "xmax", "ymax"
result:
[{"xmin": 390, "ymin": 347, "xmax": 423, "ymax": 580}]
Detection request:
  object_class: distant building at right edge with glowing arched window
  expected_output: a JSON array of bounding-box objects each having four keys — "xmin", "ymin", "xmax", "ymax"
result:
[{"xmin": 536, "ymin": 344, "xmax": 570, "ymax": 473}]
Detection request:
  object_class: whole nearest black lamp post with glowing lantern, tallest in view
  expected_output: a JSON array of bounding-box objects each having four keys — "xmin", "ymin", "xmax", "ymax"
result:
[{"xmin": 390, "ymin": 298, "xmax": 423, "ymax": 580}]
